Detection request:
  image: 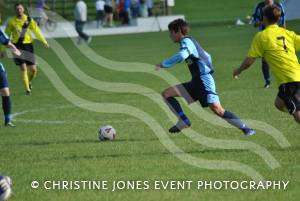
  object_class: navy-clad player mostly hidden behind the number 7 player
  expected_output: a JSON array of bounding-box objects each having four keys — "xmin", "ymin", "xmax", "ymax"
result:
[{"xmin": 252, "ymin": 0, "xmax": 285, "ymax": 88}]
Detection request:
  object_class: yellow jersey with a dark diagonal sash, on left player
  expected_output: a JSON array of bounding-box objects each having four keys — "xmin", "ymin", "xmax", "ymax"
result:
[{"xmin": 5, "ymin": 15, "xmax": 47, "ymax": 44}]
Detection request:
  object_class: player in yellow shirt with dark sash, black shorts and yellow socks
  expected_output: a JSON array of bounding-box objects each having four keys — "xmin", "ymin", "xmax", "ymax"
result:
[{"xmin": 5, "ymin": 3, "xmax": 49, "ymax": 95}]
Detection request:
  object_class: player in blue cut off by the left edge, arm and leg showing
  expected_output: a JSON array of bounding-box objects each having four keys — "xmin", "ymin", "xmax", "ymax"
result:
[{"xmin": 0, "ymin": 29, "xmax": 21, "ymax": 127}]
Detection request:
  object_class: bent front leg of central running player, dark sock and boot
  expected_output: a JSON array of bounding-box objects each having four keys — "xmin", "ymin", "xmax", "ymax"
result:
[{"xmin": 162, "ymin": 86, "xmax": 191, "ymax": 133}]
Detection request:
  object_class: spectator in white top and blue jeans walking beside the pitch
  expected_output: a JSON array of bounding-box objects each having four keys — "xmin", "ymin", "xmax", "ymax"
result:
[{"xmin": 75, "ymin": 0, "xmax": 92, "ymax": 44}]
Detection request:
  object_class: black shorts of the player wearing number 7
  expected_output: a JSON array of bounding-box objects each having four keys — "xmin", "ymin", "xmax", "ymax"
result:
[{"xmin": 278, "ymin": 82, "xmax": 300, "ymax": 114}]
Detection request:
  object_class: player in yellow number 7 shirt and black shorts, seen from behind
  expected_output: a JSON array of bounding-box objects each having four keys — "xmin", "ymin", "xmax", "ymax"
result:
[{"xmin": 233, "ymin": 5, "xmax": 300, "ymax": 123}]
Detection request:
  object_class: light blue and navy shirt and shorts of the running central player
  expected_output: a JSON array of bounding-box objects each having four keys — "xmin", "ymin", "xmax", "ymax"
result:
[{"xmin": 161, "ymin": 37, "xmax": 219, "ymax": 107}]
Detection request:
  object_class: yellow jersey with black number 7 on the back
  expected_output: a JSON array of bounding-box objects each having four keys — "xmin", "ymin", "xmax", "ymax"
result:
[{"xmin": 248, "ymin": 24, "xmax": 300, "ymax": 86}]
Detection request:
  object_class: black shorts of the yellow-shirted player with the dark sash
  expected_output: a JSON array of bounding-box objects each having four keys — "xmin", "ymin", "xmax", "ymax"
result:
[{"xmin": 14, "ymin": 43, "xmax": 35, "ymax": 66}]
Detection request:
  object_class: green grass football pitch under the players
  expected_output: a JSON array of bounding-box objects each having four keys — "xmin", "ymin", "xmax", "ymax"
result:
[{"xmin": 0, "ymin": 1, "xmax": 300, "ymax": 201}]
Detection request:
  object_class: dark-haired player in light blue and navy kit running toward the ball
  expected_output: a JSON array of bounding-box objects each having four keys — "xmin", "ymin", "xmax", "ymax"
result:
[{"xmin": 156, "ymin": 19, "xmax": 255, "ymax": 135}]
